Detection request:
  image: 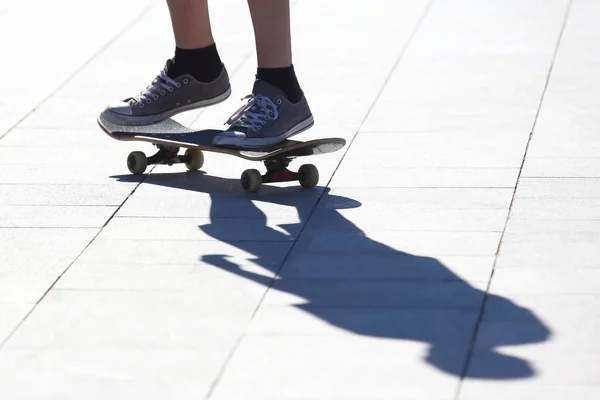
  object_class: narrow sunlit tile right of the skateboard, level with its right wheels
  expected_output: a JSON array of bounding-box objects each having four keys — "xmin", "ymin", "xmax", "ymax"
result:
[{"xmin": 331, "ymin": 164, "xmax": 519, "ymax": 188}]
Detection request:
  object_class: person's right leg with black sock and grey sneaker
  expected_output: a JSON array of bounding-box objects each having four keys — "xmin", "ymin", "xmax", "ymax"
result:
[{"xmin": 214, "ymin": 0, "xmax": 314, "ymax": 147}]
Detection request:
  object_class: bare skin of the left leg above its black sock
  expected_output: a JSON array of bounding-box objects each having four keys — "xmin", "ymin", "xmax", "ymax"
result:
[{"xmin": 167, "ymin": 0, "xmax": 214, "ymax": 49}]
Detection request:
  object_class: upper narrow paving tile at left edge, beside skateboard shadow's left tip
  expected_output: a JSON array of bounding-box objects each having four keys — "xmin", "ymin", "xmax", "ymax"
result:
[{"xmin": 0, "ymin": 184, "xmax": 133, "ymax": 207}]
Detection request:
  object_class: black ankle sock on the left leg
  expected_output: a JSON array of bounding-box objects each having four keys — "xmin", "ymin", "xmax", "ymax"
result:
[{"xmin": 167, "ymin": 44, "xmax": 223, "ymax": 82}]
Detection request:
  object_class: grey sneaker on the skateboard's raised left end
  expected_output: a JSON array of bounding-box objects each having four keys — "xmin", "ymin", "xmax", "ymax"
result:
[{"xmin": 104, "ymin": 60, "xmax": 231, "ymax": 125}]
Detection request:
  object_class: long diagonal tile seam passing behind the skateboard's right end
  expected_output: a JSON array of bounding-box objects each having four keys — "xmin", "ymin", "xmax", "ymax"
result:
[{"xmin": 204, "ymin": 0, "xmax": 435, "ymax": 400}]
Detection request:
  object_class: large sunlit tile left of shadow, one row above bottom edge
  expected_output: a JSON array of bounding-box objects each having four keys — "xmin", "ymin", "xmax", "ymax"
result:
[{"xmin": 5, "ymin": 288, "xmax": 255, "ymax": 350}]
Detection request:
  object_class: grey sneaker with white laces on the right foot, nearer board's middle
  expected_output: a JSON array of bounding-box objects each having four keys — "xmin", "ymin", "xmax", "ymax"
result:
[{"xmin": 213, "ymin": 79, "xmax": 314, "ymax": 148}]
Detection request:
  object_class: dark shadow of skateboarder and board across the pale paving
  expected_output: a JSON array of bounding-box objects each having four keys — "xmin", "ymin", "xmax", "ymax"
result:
[{"xmin": 118, "ymin": 172, "xmax": 550, "ymax": 379}]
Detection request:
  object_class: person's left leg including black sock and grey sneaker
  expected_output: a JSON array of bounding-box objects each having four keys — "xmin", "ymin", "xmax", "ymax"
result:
[{"xmin": 104, "ymin": 0, "xmax": 231, "ymax": 125}]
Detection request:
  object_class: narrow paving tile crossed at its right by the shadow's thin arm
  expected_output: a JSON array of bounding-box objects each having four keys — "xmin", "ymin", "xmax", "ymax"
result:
[{"xmin": 79, "ymin": 239, "xmax": 292, "ymax": 267}]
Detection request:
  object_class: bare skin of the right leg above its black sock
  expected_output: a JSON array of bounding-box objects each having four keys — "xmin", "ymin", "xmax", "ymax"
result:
[{"xmin": 247, "ymin": 0, "xmax": 292, "ymax": 68}]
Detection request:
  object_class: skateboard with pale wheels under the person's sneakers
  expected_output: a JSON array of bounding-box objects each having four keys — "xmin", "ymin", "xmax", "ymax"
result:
[{"xmin": 98, "ymin": 114, "xmax": 346, "ymax": 193}]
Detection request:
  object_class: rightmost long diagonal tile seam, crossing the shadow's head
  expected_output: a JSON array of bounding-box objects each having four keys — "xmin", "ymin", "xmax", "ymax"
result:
[{"xmin": 454, "ymin": 0, "xmax": 573, "ymax": 400}]
